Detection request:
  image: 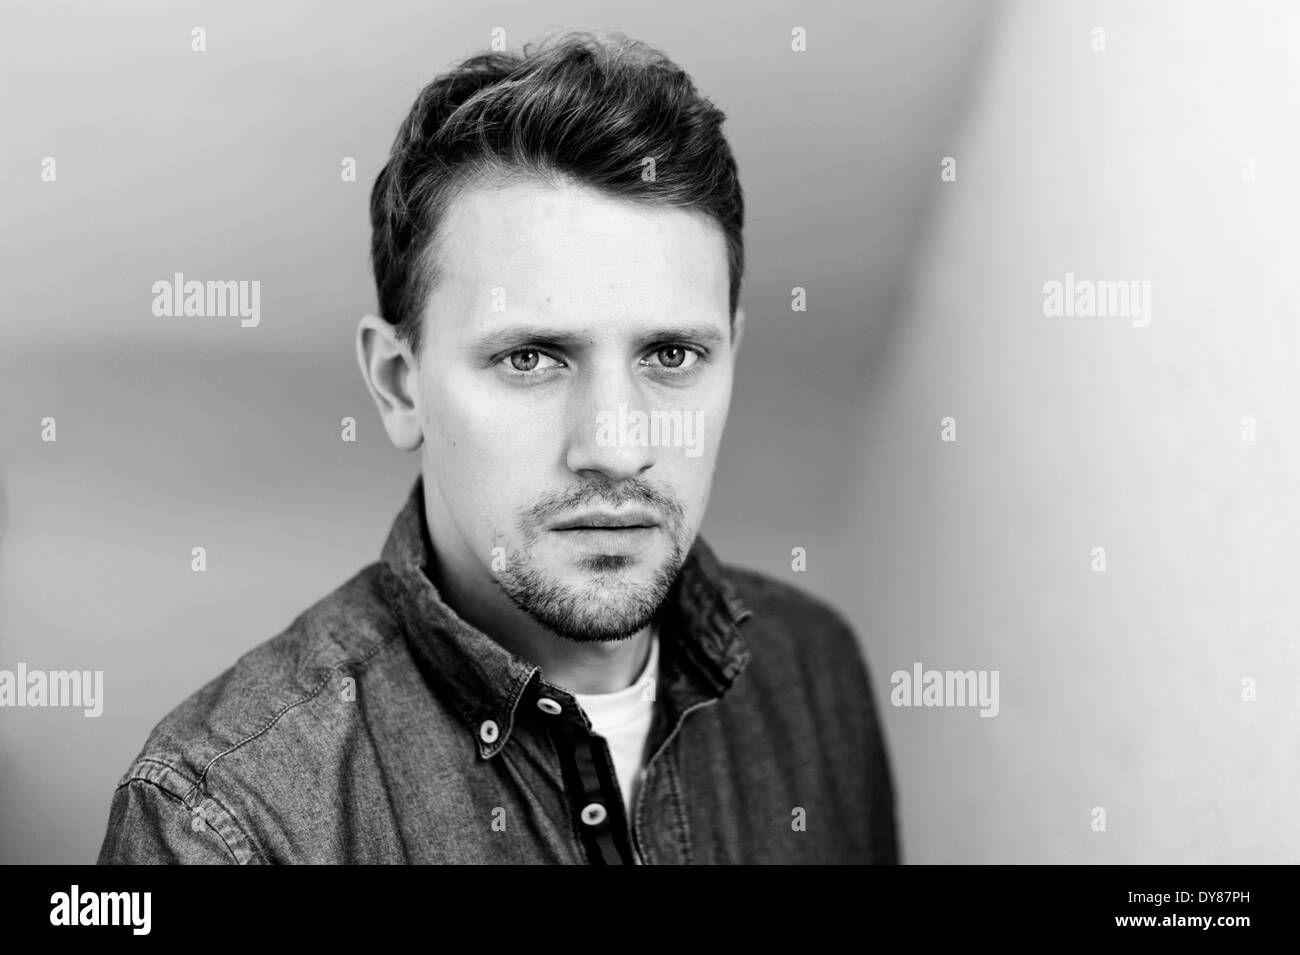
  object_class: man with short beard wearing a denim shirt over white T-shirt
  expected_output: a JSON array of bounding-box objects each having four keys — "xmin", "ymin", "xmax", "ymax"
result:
[{"xmin": 100, "ymin": 34, "xmax": 897, "ymax": 864}]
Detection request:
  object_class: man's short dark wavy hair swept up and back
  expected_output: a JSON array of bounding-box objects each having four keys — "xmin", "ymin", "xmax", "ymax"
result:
[{"xmin": 371, "ymin": 32, "xmax": 745, "ymax": 355}]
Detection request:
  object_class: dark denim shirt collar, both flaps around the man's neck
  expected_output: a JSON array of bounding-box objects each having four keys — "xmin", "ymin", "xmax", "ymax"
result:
[{"xmin": 382, "ymin": 477, "xmax": 751, "ymax": 758}]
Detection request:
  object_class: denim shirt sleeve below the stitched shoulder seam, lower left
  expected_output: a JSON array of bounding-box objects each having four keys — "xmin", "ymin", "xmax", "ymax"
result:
[{"xmin": 99, "ymin": 763, "xmax": 260, "ymax": 865}]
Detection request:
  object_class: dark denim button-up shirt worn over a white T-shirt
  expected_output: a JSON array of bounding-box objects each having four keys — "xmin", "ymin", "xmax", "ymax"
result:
[{"xmin": 99, "ymin": 479, "xmax": 898, "ymax": 864}]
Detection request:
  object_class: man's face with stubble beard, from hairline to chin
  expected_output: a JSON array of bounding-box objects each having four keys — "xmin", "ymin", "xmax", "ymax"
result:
[{"xmin": 415, "ymin": 176, "xmax": 735, "ymax": 641}]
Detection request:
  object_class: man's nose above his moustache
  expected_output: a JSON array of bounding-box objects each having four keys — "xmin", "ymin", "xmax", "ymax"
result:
[{"xmin": 564, "ymin": 369, "xmax": 658, "ymax": 483}]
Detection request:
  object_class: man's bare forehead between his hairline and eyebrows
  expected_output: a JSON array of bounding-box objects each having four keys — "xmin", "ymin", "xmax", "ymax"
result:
[{"xmin": 430, "ymin": 181, "xmax": 729, "ymax": 322}]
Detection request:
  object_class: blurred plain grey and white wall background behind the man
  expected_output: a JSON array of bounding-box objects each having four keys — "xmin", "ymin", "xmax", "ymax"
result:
[{"xmin": 0, "ymin": 0, "xmax": 1300, "ymax": 863}]
